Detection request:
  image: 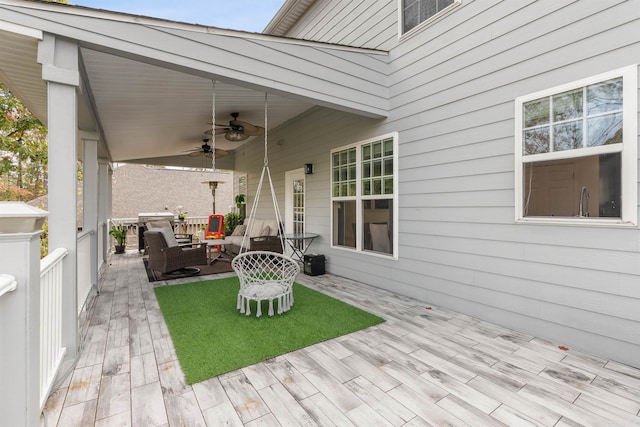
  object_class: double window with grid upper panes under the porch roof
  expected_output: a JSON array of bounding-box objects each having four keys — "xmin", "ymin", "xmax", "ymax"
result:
[{"xmin": 331, "ymin": 134, "xmax": 398, "ymax": 257}]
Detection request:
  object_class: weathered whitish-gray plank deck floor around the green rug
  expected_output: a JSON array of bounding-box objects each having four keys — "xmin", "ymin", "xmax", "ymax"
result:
[{"xmin": 43, "ymin": 252, "xmax": 640, "ymax": 427}]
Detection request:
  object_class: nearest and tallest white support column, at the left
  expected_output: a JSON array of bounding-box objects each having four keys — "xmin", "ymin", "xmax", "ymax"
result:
[{"xmin": 38, "ymin": 34, "xmax": 80, "ymax": 358}]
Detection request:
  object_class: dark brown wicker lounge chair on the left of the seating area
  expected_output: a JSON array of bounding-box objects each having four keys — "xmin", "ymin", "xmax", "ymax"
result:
[{"xmin": 144, "ymin": 230, "xmax": 207, "ymax": 274}]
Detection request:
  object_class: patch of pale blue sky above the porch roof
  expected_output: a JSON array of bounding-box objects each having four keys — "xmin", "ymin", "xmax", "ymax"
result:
[{"xmin": 69, "ymin": 0, "xmax": 284, "ymax": 32}]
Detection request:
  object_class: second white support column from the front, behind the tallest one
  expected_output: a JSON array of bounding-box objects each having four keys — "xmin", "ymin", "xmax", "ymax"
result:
[{"xmin": 80, "ymin": 131, "xmax": 99, "ymax": 294}]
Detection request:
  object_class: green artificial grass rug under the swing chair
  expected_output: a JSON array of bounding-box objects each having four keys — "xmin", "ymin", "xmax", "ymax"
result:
[{"xmin": 154, "ymin": 277, "xmax": 384, "ymax": 384}]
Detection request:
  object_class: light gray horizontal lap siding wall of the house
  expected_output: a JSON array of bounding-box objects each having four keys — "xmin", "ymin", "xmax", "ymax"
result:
[{"xmin": 238, "ymin": 0, "xmax": 640, "ymax": 366}]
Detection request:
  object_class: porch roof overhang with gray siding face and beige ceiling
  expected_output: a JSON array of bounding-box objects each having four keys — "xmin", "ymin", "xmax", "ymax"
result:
[{"xmin": 0, "ymin": 0, "xmax": 388, "ymax": 167}]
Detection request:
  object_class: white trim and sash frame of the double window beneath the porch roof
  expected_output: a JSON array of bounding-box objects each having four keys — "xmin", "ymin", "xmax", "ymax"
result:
[{"xmin": 329, "ymin": 132, "xmax": 399, "ymax": 260}]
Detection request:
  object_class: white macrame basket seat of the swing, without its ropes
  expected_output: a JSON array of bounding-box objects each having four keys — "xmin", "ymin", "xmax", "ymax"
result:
[{"xmin": 231, "ymin": 251, "xmax": 300, "ymax": 317}]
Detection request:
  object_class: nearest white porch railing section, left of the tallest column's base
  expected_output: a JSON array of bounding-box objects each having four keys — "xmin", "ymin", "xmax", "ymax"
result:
[{"xmin": 40, "ymin": 248, "xmax": 68, "ymax": 410}]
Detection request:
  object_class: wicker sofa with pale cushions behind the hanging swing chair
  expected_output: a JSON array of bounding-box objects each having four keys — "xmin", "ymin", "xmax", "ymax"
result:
[{"xmin": 225, "ymin": 218, "xmax": 282, "ymax": 254}]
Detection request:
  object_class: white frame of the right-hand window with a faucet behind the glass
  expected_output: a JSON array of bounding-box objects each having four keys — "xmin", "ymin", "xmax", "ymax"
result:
[{"xmin": 514, "ymin": 64, "xmax": 638, "ymax": 226}]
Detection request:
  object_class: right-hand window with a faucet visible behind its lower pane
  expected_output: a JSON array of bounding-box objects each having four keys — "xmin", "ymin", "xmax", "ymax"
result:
[{"xmin": 516, "ymin": 65, "xmax": 638, "ymax": 224}]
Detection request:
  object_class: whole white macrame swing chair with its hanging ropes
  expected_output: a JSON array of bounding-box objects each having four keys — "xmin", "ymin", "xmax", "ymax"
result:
[{"xmin": 231, "ymin": 94, "xmax": 300, "ymax": 317}]
